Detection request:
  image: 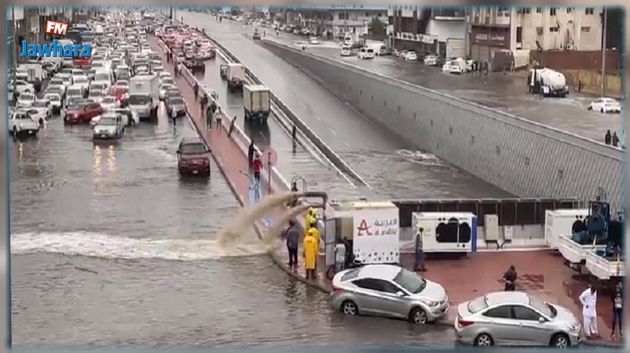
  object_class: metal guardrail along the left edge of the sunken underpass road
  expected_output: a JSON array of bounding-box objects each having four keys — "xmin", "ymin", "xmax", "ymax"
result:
[{"xmin": 200, "ymin": 32, "xmax": 372, "ymax": 189}]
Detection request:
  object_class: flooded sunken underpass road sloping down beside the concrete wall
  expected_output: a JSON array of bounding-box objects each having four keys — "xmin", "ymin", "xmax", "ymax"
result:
[{"xmin": 179, "ymin": 11, "xmax": 509, "ymax": 199}]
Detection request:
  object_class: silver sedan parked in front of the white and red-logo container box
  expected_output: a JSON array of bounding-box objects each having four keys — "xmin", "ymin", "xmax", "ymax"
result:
[{"xmin": 331, "ymin": 264, "xmax": 449, "ymax": 324}]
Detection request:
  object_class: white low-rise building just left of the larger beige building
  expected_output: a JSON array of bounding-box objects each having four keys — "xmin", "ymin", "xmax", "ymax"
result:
[{"xmin": 387, "ymin": 5, "xmax": 466, "ymax": 57}]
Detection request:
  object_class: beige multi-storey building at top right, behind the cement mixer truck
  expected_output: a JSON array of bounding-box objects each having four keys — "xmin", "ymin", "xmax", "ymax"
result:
[{"xmin": 466, "ymin": 7, "xmax": 603, "ymax": 71}]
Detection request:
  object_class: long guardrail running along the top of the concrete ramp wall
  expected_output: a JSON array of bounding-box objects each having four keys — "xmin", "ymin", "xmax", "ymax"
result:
[{"xmin": 262, "ymin": 39, "xmax": 624, "ymax": 162}]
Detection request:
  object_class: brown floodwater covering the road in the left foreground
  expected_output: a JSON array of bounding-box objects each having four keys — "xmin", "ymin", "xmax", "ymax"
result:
[{"xmin": 11, "ymin": 41, "xmax": 453, "ymax": 347}]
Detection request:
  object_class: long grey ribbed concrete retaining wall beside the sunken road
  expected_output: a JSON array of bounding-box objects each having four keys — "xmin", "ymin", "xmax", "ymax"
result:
[{"xmin": 262, "ymin": 40, "xmax": 624, "ymax": 209}]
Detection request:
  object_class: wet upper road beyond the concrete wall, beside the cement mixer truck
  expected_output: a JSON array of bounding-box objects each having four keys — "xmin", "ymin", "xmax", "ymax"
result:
[{"xmin": 266, "ymin": 32, "xmax": 622, "ymax": 142}]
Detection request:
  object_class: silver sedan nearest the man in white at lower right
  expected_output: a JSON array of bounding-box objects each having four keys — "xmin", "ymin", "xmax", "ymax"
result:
[{"xmin": 455, "ymin": 292, "xmax": 581, "ymax": 348}]
